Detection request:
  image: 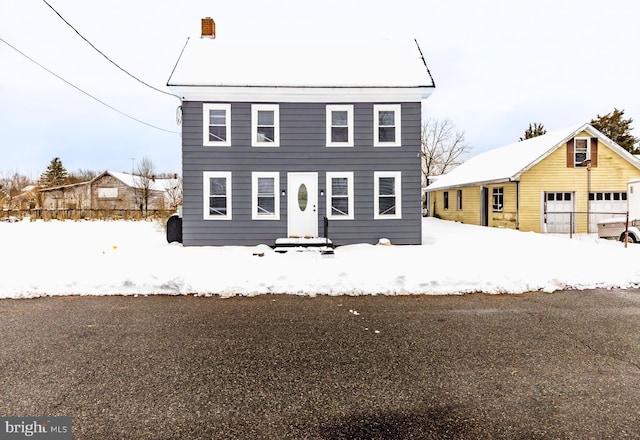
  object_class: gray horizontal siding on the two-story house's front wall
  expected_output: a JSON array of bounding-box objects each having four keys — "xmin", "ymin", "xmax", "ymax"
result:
[{"xmin": 182, "ymin": 102, "xmax": 421, "ymax": 246}]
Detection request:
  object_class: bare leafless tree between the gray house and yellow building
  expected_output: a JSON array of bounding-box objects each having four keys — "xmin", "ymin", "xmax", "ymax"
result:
[{"xmin": 420, "ymin": 119, "xmax": 471, "ymax": 186}]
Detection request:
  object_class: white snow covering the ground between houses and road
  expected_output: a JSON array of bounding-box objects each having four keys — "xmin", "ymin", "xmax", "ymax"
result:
[{"xmin": 0, "ymin": 218, "xmax": 640, "ymax": 298}]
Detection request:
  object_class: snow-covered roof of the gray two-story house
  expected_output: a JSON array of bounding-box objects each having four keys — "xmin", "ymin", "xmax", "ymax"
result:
[{"xmin": 167, "ymin": 38, "xmax": 434, "ymax": 102}]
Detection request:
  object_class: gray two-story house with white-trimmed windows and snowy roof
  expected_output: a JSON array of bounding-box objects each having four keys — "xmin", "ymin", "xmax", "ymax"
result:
[{"xmin": 167, "ymin": 22, "xmax": 434, "ymax": 245}]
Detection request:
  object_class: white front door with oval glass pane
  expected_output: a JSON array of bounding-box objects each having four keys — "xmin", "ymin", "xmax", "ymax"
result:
[{"xmin": 287, "ymin": 173, "xmax": 318, "ymax": 237}]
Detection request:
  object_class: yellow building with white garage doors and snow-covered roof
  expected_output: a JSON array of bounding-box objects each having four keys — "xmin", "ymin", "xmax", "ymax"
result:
[{"xmin": 426, "ymin": 124, "xmax": 640, "ymax": 233}]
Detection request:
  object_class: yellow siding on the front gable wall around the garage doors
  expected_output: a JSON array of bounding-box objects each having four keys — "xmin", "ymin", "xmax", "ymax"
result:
[{"xmin": 520, "ymin": 133, "xmax": 640, "ymax": 233}]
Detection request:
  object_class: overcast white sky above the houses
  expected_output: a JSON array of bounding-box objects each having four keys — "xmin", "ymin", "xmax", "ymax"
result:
[{"xmin": 0, "ymin": 0, "xmax": 640, "ymax": 178}]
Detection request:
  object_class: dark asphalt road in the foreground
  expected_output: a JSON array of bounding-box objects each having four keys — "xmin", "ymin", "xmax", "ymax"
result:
[{"xmin": 0, "ymin": 290, "xmax": 640, "ymax": 439}]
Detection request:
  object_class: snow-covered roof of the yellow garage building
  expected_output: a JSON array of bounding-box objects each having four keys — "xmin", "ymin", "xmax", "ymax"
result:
[{"xmin": 426, "ymin": 124, "xmax": 640, "ymax": 192}]
